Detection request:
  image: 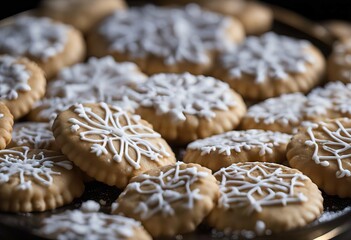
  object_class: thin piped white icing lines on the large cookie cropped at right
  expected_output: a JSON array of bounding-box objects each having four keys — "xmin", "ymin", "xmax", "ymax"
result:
[{"xmin": 305, "ymin": 120, "xmax": 351, "ymax": 178}]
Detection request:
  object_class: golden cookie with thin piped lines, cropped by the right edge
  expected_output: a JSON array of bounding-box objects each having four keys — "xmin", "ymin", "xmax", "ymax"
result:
[{"xmin": 287, "ymin": 118, "xmax": 351, "ymax": 198}]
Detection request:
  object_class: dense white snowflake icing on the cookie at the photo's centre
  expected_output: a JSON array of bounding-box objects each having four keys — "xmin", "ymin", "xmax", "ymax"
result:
[{"xmin": 126, "ymin": 73, "xmax": 237, "ymax": 121}]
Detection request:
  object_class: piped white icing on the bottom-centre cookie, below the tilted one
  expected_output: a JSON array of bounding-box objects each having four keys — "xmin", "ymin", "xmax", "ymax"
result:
[{"xmin": 122, "ymin": 162, "xmax": 208, "ymax": 219}]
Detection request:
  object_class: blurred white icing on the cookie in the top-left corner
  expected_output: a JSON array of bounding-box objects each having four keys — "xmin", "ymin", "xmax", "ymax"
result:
[{"xmin": 0, "ymin": 16, "xmax": 69, "ymax": 61}]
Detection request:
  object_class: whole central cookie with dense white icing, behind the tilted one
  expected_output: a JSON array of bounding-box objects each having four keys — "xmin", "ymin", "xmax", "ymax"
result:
[{"xmin": 126, "ymin": 73, "xmax": 246, "ymax": 145}]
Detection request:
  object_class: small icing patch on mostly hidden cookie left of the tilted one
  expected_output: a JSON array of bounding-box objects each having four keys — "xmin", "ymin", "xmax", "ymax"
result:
[{"xmin": 12, "ymin": 122, "xmax": 55, "ymax": 149}]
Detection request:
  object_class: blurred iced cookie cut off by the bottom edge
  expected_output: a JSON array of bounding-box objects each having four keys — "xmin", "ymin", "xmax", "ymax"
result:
[{"xmin": 35, "ymin": 201, "xmax": 152, "ymax": 240}]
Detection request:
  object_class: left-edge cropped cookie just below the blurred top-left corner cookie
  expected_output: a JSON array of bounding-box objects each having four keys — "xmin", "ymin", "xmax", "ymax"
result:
[{"xmin": 0, "ymin": 54, "xmax": 46, "ymax": 119}]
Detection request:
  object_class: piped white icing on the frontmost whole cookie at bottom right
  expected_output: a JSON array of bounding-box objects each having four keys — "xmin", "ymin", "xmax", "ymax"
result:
[{"xmin": 214, "ymin": 163, "xmax": 308, "ymax": 214}]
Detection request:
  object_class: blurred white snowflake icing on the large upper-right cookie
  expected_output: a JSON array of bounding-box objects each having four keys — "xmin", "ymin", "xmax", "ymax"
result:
[{"xmin": 221, "ymin": 32, "xmax": 314, "ymax": 83}]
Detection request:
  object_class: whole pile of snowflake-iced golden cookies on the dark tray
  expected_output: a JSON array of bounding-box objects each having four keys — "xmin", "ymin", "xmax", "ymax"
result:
[{"xmin": 0, "ymin": 0, "xmax": 351, "ymax": 239}]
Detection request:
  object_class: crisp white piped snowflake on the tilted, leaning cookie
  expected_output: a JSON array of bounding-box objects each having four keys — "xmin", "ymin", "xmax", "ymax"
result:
[{"xmin": 68, "ymin": 102, "xmax": 170, "ymax": 169}]
